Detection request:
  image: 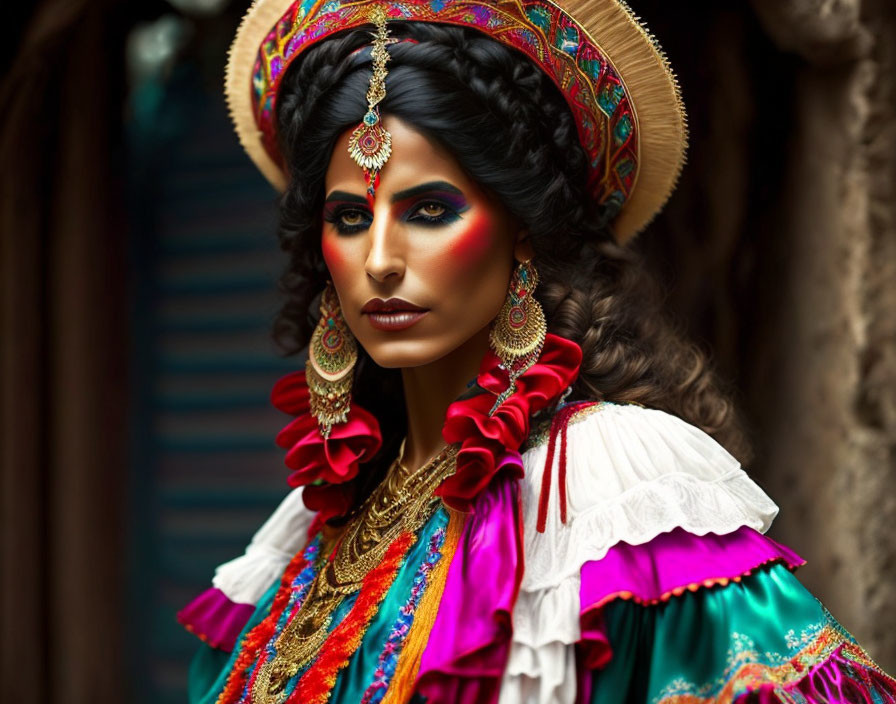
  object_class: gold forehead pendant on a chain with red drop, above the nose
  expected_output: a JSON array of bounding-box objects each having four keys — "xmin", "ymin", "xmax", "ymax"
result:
[{"xmin": 348, "ymin": 7, "xmax": 392, "ymax": 207}]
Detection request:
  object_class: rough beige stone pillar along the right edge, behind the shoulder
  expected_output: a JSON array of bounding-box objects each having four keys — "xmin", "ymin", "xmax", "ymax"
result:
[{"xmin": 754, "ymin": 0, "xmax": 896, "ymax": 672}]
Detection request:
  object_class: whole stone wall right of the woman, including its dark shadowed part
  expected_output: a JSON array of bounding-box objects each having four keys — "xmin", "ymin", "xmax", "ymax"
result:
[{"xmin": 634, "ymin": 0, "xmax": 896, "ymax": 672}]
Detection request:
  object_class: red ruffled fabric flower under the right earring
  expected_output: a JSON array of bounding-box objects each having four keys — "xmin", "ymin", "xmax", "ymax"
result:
[{"xmin": 436, "ymin": 335, "xmax": 582, "ymax": 511}]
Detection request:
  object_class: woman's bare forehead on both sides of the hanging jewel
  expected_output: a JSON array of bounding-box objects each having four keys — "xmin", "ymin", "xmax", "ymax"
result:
[{"xmin": 325, "ymin": 115, "xmax": 472, "ymax": 195}]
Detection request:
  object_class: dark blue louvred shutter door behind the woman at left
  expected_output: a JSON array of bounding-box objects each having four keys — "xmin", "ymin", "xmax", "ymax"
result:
[{"xmin": 128, "ymin": 62, "xmax": 297, "ymax": 704}]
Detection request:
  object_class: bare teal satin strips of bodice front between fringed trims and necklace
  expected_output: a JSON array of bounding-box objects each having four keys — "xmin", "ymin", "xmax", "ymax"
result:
[{"xmin": 189, "ymin": 508, "xmax": 448, "ymax": 704}]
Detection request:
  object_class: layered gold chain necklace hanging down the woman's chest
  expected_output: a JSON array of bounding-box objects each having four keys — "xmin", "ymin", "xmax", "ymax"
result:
[{"xmin": 252, "ymin": 442, "xmax": 457, "ymax": 704}]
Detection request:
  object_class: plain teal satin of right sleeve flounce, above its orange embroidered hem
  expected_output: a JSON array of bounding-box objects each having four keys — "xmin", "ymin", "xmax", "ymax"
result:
[{"xmin": 590, "ymin": 564, "xmax": 851, "ymax": 704}]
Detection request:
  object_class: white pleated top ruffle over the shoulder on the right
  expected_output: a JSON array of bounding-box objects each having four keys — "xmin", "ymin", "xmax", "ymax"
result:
[{"xmin": 521, "ymin": 404, "xmax": 778, "ymax": 591}]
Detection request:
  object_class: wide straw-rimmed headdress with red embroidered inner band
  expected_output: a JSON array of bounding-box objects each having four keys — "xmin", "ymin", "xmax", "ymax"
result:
[{"xmin": 226, "ymin": 0, "xmax": 687, "ymax": 242}]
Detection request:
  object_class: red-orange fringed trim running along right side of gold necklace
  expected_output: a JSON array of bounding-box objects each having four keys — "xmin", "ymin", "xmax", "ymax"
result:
[{"xmin": 287, "ymin": 533, "xmax": 416, "ymax": 704}]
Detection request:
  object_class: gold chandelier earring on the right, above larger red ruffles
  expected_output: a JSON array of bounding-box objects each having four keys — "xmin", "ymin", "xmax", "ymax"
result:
[{"xmin": 488, "ymin": 261, "xmax": 548, "ymax": 415}]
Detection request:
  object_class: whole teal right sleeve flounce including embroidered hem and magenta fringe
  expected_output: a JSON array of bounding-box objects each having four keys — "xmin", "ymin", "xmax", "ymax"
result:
[{"xmin": 583, "ymin": 563, "xmax": 896, "ymax": 704}]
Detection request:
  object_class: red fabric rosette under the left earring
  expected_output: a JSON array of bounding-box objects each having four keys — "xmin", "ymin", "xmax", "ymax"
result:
[{"xmin": 271, "ymin": 371, "xmax": 383, "ymax": 520}]
